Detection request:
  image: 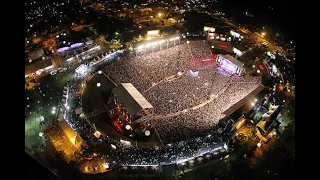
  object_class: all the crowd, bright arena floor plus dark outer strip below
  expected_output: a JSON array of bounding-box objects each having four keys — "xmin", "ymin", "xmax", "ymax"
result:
[{"xmin": 59, "ymin": 41, "xmax": 260, "ymax": 170}]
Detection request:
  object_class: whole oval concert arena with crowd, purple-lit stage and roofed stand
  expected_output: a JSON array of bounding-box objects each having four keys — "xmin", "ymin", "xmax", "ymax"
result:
[{"xmin": 82, "ymin": 36, "xmax": 264, "ymax": 165}]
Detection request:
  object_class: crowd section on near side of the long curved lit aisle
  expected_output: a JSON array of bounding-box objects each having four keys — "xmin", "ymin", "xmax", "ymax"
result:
[{"xmin": 150, "ymin": 77, "xmax": 259, "ymax": 142}]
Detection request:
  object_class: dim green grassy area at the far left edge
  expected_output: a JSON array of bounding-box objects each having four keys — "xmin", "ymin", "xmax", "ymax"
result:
[{"xmin": 25, "ymin": 70, "xmax": 68, "ymax": 150}]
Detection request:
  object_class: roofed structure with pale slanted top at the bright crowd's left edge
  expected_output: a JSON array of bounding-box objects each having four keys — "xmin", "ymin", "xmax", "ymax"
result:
[{"xmin": 112, "ymin": 83, "xmax": 153, "ymax": 116}]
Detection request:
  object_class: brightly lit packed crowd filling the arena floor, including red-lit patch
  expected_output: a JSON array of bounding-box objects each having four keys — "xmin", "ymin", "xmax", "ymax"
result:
[{"xmin": 104, "ymin": 39, "xmax": 262, "ymax": 144}]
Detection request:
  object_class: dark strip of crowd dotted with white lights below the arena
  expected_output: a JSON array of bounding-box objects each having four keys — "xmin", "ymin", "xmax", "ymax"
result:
[{"xmin": 117, "ymin": 129, "xmax": 225, "ymax": 166}]
